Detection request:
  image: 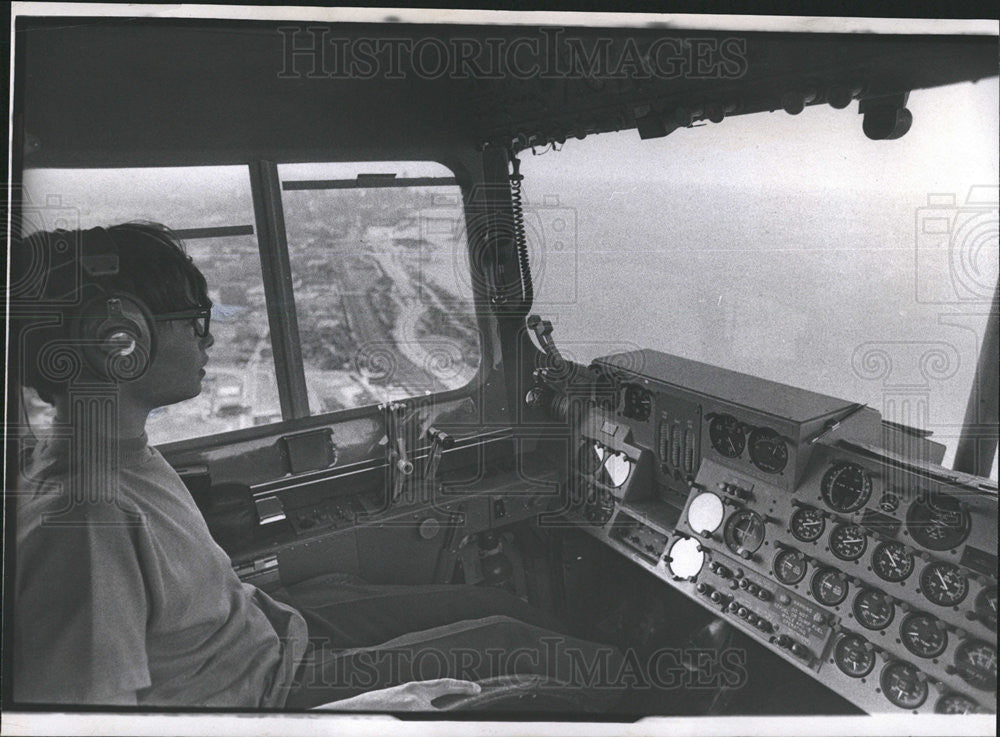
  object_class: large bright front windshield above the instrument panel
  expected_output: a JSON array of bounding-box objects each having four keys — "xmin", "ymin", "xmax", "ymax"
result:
[{"xmin": 520, "ymin": 79, "xmax": 998, "ymax": 478}]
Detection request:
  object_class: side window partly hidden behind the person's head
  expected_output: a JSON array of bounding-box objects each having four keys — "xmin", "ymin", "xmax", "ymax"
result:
[{"xmin": 22, "ymin": 166, "xmax": 281, "ymax": 444}]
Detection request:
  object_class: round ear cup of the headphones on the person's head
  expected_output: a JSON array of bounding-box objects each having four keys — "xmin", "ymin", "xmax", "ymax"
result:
[{"xmin": 74, "ymin": 294, "xmax": 156, "ymax": 382}]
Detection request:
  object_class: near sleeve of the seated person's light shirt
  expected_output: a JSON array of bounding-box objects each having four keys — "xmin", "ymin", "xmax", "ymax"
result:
[{"xmin": 13, "ymin": 502, "xmax": 150, "ymax": 704}]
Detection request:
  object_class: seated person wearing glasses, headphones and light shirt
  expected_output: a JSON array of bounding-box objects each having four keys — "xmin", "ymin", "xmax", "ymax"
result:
[{"xmin": 12, "ymin": 223, "xmax": 621, "ymax": 711}]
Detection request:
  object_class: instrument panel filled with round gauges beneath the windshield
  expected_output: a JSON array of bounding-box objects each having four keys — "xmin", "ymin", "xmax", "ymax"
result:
[{"xmin": 569, "ymin": 351, "xmax": 997, "ymax": 713}]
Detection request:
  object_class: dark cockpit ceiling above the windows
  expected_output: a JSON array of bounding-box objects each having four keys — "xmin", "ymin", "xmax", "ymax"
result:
[{"xmin": 17, "ymin": 18, "xmax": 997, "ymax": 166}]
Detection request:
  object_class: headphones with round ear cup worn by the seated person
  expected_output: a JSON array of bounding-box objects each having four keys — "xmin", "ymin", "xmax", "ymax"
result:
[{"xmin": 71, "ymin": 228, "xmax": 157, "ymax": 382}]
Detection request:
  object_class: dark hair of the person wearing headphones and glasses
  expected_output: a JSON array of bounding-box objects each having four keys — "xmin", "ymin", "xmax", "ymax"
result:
[{"xmin": 11, "ymin": 222, "xmax": 212, "ymax": 404}]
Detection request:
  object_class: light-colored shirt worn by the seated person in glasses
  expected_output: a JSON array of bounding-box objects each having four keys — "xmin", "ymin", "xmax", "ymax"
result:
[{"xmin": 13, "ymin": 437, "xmax": 308, "ymax": 707}]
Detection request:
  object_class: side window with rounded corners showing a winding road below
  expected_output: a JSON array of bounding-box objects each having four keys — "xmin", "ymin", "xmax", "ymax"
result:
[{"xmin": 278, "ymin": 161, "xmax": 480, "ymax": 414}]
